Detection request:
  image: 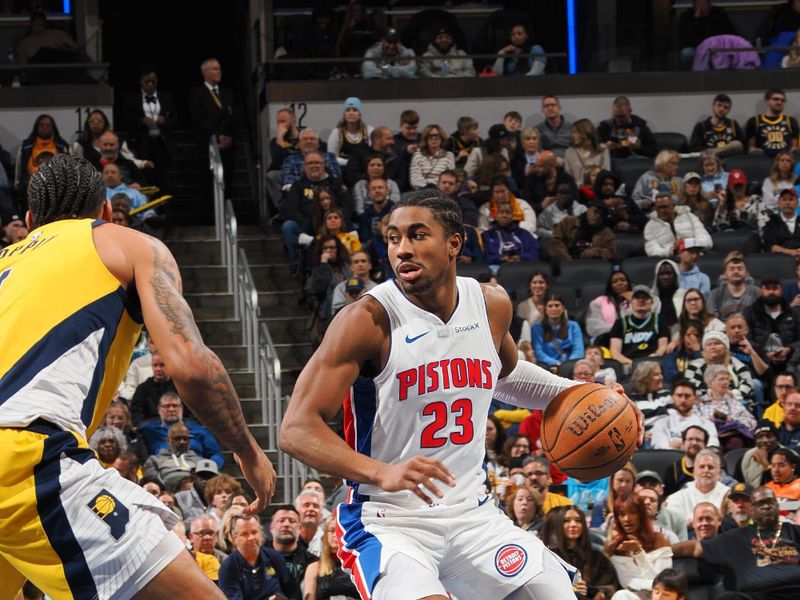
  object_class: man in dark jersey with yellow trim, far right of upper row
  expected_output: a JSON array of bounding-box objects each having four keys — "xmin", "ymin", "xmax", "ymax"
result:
[{"xmin": 744, "ymin": 88, "xmax": 800, "ymax": 156}]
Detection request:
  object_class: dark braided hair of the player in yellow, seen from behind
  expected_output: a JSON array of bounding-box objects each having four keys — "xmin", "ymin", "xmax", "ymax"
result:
[{"xmin": 28, "ymin": 154, "xmax": 105, "ymax": 228}]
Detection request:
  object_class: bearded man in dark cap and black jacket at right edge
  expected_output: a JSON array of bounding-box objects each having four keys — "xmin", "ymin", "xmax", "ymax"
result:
[{"xmin": 744, "ymin": 274, "xmax": 800, "ymax": 371}]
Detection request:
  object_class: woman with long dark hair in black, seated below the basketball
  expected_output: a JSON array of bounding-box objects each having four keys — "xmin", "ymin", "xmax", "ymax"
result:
[{"xmin": 539, "ymin": 506, "xmax": 619, "ymax": 600}]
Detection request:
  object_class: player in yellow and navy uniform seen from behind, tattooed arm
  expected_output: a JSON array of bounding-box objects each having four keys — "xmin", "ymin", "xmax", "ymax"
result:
[{"xmin": 0, "ymin": 155, "xmax": 275, "ymax": 600}]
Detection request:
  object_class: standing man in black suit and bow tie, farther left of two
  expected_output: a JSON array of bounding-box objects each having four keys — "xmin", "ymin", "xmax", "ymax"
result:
[{"xmin": 122, "ymin": 66, "xmax": 178, "ymax": 190}]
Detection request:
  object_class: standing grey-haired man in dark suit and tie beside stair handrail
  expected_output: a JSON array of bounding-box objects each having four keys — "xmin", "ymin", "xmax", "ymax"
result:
[{"xmin": 189, "ymin": 58, "xmax": 234, "ymax": 190}]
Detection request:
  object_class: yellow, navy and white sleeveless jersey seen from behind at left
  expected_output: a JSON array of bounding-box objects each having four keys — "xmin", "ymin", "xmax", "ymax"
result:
[{"xmin": 0, "ymin": 219, "xmax": 142, "ymax": 437}]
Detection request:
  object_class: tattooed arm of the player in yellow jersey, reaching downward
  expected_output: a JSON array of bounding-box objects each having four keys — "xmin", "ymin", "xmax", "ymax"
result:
[{"xmin": 123, "ymin": 232, "xmax": 276, "ymax": 512}]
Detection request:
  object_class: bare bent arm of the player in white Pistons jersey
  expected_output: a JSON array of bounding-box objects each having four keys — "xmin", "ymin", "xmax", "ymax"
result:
[{"xmin": 280, "ymin": 296, "xmax": 453, "ymax": 503}]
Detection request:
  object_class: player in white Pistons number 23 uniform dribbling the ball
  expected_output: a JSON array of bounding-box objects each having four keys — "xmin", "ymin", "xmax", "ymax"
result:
[{"xmin": 280, "ymin": 190, "xmax": 642, "ymax": 600}]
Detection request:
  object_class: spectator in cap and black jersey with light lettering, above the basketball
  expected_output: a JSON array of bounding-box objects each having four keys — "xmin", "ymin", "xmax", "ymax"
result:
[{"xmin": 609, "ymin": 285, "xmax": 667, "ymax": 369}]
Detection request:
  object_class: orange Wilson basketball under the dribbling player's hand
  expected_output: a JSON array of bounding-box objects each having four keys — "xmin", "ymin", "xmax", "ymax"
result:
[{"xmin": 541, "ymin": 383, "xmax": 638, "ymax": 481}]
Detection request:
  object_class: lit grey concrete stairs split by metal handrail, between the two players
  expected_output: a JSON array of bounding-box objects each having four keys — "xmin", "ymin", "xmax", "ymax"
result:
[{"xmin": 167, "ymin": 226, "xmax": 311, "ymax": 497}]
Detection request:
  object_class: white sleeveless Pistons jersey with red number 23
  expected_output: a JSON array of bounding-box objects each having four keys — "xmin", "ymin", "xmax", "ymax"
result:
[{"xmin": 344, "ymin": 277, "xmax": 501, "ymax": 506}]
